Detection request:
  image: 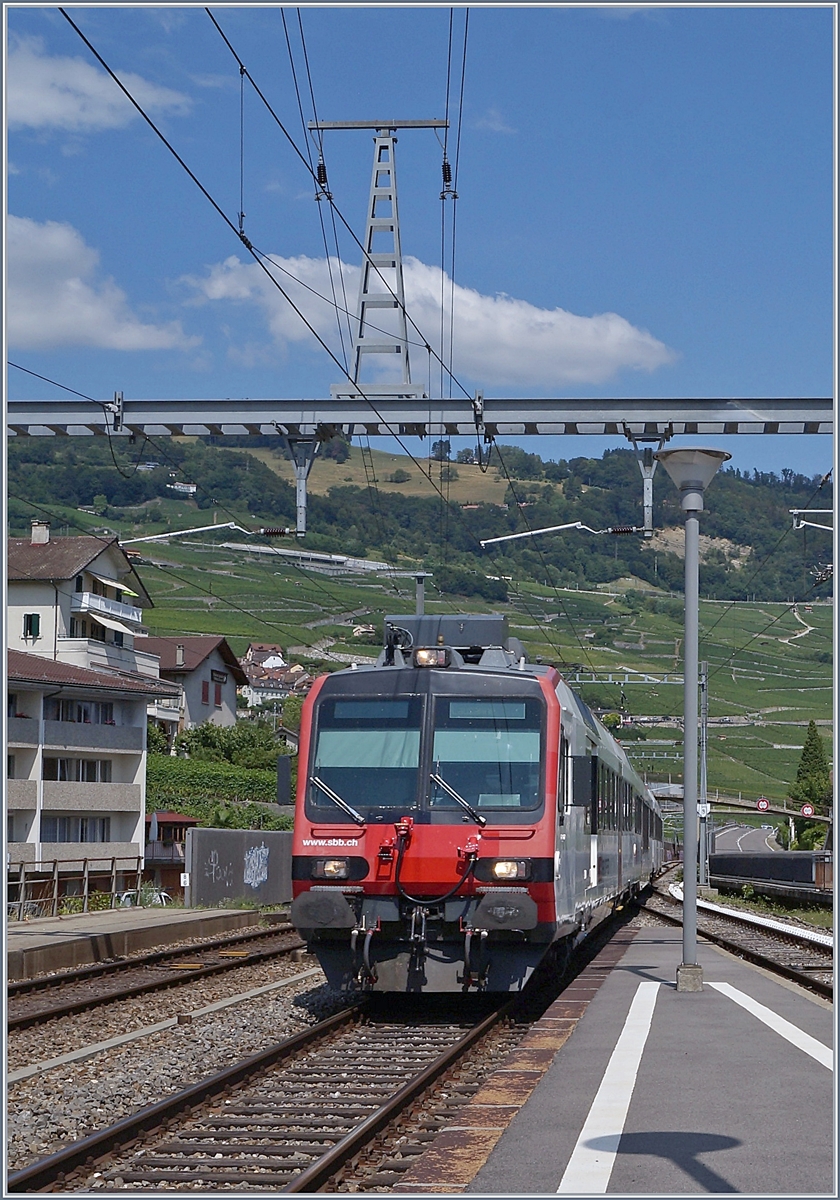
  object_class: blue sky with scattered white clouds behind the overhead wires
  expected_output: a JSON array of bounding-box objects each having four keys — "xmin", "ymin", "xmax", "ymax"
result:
[{"xmin": 6, "ymin": 5, "xmax": 835, "ymax": 475}]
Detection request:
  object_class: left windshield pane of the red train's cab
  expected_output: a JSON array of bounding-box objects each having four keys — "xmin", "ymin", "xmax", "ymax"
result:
[{"xmin": 306, "ymin": 696, "xmax": 424, "ymax": 822}]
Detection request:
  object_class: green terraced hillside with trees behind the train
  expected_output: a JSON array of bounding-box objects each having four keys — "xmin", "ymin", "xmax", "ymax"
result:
[{"xmin": 8, "ymin": 438, "xmax": 833, "ymax": 799}]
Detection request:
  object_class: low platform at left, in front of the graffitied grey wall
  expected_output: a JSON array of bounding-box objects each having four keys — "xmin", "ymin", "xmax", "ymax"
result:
[{"xmin": 6, "ymin": 906, "xmax": 259, "ymax": 980}]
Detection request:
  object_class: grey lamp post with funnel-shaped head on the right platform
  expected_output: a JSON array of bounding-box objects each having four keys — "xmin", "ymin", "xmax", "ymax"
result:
[{"xmin": 654, "ymin": 449, "xmax": 732, "ymax": 991}]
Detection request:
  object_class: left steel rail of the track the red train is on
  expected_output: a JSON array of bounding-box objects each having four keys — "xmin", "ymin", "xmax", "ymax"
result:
[{"xmin": 7, "ymin": 1004, "xmax": 364, "ymax": 1193}]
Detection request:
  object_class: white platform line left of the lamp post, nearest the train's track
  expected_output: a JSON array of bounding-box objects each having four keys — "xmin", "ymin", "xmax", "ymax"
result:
[{"xmin": 557, "ymin": 983, "xmax": 659, "ymax": 1195}]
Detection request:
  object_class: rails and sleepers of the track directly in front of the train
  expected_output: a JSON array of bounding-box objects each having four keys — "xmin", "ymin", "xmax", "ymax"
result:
[{"xmin": 8, "ymin": 1004, "xmax": 510, "ymax": 1192}]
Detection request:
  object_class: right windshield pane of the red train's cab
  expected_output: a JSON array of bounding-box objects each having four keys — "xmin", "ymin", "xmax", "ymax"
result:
[{"xmin": 430, "ymin": 696, "xmax": 544, "ymax": 821}]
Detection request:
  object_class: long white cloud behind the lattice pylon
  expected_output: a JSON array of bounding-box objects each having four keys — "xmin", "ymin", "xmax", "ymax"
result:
[{"xmin": 185, "ymin": 256, "xmax": 676, "ymax": 390}]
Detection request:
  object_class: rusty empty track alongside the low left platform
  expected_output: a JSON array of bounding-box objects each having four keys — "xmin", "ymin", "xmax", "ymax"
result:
[{"xmin": 7, "ymin": 923, "xmax": 305, "ymax": 1031}]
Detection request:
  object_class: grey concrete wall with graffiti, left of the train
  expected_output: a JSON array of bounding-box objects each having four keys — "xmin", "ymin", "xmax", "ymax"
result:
[{"xmin": 185, "ymin": 829, "xmax": 292, "ymax": 906}]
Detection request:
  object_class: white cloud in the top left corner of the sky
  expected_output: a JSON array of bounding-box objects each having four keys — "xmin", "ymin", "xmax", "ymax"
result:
[{"xmin": 6, "ymin": 38, "xmax": 192, "ymax": 132}]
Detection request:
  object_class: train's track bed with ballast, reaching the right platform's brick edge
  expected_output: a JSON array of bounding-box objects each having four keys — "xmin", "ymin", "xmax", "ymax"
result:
[{"xmin": 8, "ymin": 912, "xmax": 629, "ymax": 1193}]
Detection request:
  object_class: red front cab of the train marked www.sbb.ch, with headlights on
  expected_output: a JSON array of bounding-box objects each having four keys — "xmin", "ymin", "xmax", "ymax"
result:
[{"xmin": 292, "ymin": 667, "xmax": 563, "ymax": 992}]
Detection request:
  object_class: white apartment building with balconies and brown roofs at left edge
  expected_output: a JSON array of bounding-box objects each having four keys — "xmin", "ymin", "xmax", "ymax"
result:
[{"xmin": 6, "ymin": 521, "xmax": 180, "ymax": 878}]
